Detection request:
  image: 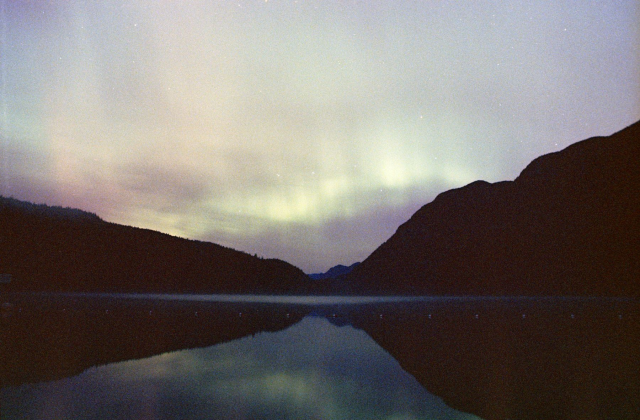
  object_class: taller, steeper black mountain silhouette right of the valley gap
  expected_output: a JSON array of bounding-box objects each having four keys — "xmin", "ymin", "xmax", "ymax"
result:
[{"xmin": 346, "ymin": 118, "xmax": 640, "ymax": 296}]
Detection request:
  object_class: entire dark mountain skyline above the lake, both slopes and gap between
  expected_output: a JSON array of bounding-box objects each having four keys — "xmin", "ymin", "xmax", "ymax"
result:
[{"xmin": 0, "ymin": 118, "xmax": 640, "ymax": 297}]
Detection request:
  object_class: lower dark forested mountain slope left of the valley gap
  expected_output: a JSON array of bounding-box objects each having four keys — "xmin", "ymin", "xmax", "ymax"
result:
[{"xmin": 0, "ymin": 197, "xmax": 310, "ymax": 293}]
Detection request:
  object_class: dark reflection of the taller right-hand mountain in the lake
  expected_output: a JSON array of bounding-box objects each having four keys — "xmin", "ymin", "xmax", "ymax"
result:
[{"xmin": 349, "ymin": 300, "xmax": 640, "ymax": 420}]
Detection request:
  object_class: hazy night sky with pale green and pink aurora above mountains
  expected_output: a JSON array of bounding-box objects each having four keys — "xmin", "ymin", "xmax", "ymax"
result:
[{"xmin": 0, "ymin": 0, "xmax": 640, "ymax": 272}]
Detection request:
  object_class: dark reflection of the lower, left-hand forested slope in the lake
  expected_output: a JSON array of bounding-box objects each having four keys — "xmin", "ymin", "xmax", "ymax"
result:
[{"xmin": 0, "ymin": 297, "xmax": 303, "ymax": 388}]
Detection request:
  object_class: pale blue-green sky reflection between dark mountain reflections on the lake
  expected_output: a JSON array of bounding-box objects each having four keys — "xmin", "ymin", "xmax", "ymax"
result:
[{"xmin": 0, "ymin": 317, "xmax": 477, "ymax": 420}]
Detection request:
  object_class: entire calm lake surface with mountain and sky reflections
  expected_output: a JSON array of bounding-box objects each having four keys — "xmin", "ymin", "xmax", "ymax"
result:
[{"xmin": 0, "ymin": 295, "xmax": 640, "ymax": 420}]
